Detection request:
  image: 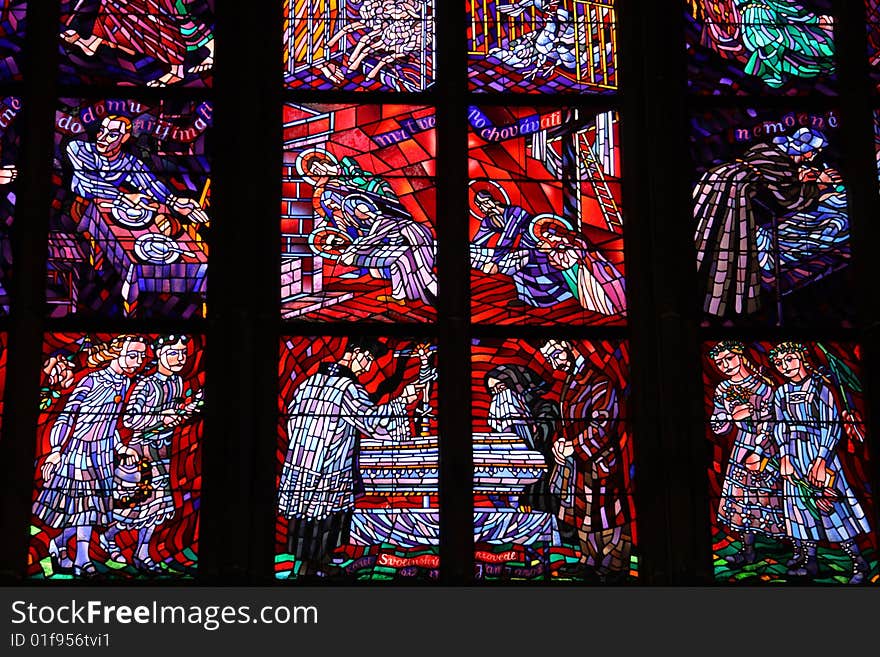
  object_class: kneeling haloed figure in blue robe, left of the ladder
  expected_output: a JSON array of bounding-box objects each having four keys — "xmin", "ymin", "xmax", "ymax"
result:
[{"xmin": 471, "ymin": 190, "xmax": 572, "ymax": 308}]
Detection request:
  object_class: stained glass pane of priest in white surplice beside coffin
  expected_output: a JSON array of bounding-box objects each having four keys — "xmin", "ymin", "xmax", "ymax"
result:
[{"xmin": 275, "ymin": 337, "xmax": 440, "ymax": 581}]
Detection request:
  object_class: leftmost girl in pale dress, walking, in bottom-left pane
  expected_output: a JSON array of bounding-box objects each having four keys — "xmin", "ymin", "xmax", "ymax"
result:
[{"xmin": 33, "ymin": 335, "xmax": 146, "ymax": 576}]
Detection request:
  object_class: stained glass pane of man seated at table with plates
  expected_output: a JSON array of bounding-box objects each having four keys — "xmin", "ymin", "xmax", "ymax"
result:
[{"xmin": 47, "ymin": 99, "xmax": 213, "ymax": 318}]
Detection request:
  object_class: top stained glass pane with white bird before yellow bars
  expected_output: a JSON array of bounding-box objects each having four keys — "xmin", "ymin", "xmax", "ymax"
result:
[{"xmin": 465, "ymin": 0, "xmax": 618, "ymax": 94}]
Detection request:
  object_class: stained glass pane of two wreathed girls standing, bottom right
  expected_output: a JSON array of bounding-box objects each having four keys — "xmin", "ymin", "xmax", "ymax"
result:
[{"xmin": 703, "ymin": 340, "xmax": 877, "ymax": 584}]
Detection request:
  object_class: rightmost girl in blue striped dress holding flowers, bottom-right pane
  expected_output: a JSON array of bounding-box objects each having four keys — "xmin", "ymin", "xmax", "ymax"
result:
[{"xmin": 770, "ymin": 342, "xmax": 871, "ymax": 584}]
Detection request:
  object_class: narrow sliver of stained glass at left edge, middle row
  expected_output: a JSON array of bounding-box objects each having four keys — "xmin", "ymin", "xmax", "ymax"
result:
[{"xmin": 0, "ymin": 96, "xmax": 22, "ymax": 314}]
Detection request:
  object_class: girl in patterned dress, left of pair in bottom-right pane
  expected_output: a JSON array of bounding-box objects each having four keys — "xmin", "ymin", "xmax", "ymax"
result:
[{"xmin": 709, "ymin": 341, "xmax": 785, "ymax": 566}]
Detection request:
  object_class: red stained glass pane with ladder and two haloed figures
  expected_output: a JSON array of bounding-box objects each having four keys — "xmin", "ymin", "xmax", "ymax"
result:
[{"xmin": 468, "ymin": 106, "xmax": 626, "ymax": 325}]
